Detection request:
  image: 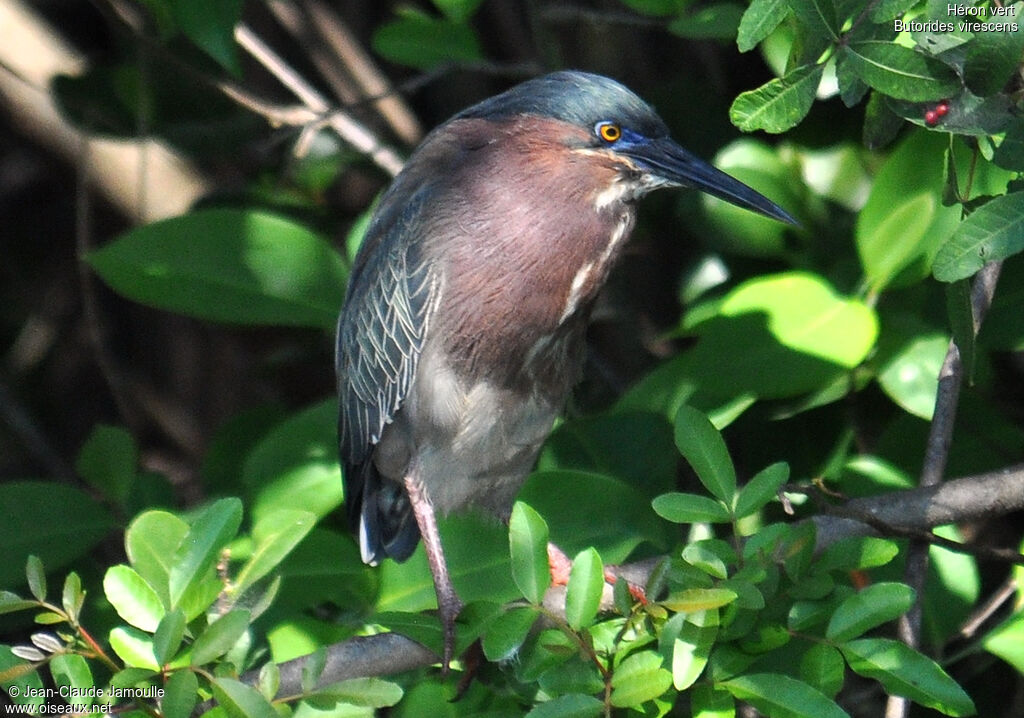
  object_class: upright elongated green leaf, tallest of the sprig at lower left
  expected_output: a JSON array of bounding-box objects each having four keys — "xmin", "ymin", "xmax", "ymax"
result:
[{"xmin": 168, "ymin": 499, "xmax": 242, "ymax": 615}]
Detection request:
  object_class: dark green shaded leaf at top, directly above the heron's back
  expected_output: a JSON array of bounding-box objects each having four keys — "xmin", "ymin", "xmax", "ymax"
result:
[{"xmin": 372, "ymin": 7, "xmax": 483, "ymax": 70}]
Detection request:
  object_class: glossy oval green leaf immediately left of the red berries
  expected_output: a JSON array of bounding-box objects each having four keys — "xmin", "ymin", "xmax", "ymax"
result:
[{"xmin": 842, "ymin": 40, "xmax": 958, "ymax": 102}]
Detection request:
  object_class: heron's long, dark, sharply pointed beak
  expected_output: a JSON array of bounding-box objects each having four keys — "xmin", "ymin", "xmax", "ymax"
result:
[{"xmin": 622, "ymin": 137, "xmax": 799, "ymax": 224}]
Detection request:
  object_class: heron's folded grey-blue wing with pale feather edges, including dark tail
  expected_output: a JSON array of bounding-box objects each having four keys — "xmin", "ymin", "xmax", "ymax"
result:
[{"xmin": 335, "ymin": 207, "xmax": 436, "ymax": 563}]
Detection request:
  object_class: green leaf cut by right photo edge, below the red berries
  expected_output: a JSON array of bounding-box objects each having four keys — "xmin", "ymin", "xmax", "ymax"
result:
[{"xmin": 932, "ymin": 192, "xmax": 1024, "ymax": 282}]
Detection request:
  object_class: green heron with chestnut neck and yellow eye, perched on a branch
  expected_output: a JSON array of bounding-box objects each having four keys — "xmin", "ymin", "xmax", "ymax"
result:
[{"xmin": 336, "ymin": 72, "xmax": 794, "ymax": 668}]
